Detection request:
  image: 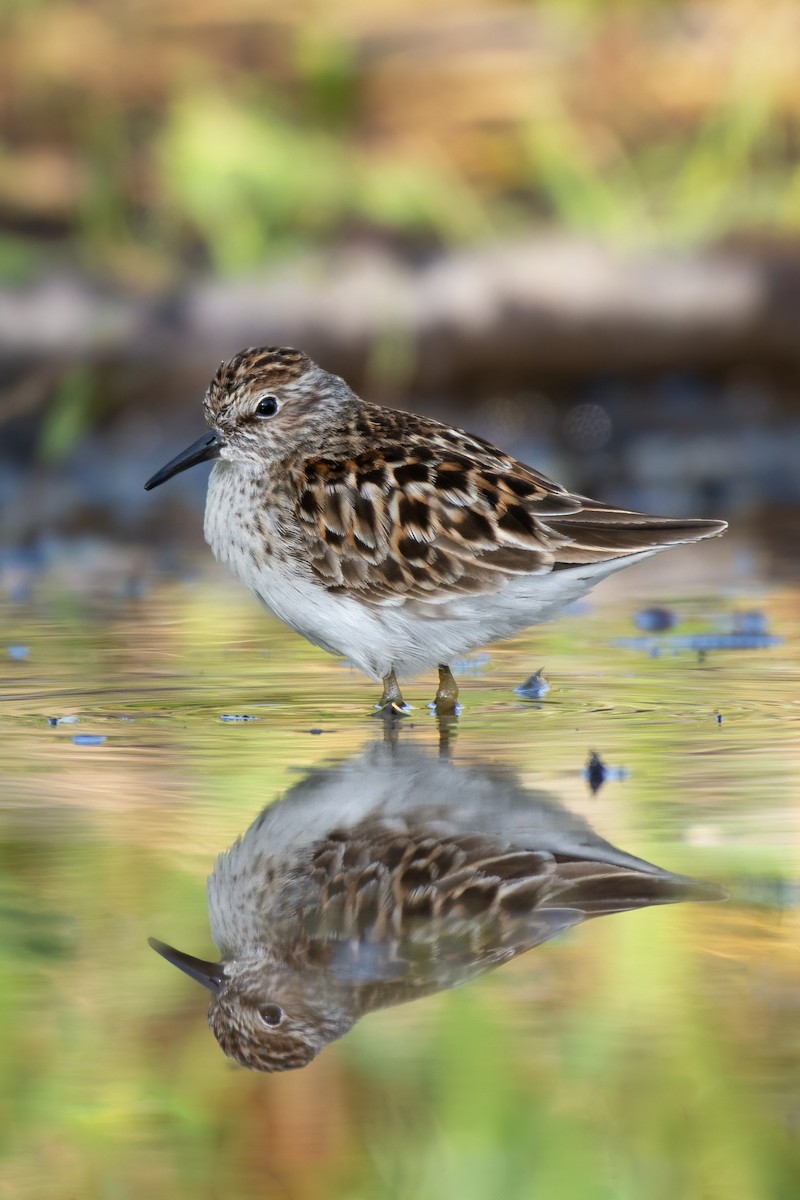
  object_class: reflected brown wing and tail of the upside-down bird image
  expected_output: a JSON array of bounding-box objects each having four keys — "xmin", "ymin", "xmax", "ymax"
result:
[{"xmin": 293, "ymin": 821, "xmax": 721, "ymax": 1009}]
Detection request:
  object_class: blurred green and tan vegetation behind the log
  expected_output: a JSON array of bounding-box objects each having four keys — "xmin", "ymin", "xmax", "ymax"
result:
[{"xmin": 0, "ymin": 0, "xmax": 800, "ymax": 278}]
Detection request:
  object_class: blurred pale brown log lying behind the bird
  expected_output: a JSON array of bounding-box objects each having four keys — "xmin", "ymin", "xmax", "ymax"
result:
[{"xmin": 0, "ymin": 239, "xmax": 800, "ymax": 386}]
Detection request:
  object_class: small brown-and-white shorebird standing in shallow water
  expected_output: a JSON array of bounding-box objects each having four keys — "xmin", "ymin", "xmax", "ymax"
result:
[{"xmin": 145, "ymin": 347, "xmax": 726, "ymax": 714}]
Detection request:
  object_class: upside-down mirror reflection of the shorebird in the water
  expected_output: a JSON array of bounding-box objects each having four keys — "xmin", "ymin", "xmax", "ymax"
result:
[{"xmin": 150, "ymin": 742, "xmax": 723, "ymax": 1070}]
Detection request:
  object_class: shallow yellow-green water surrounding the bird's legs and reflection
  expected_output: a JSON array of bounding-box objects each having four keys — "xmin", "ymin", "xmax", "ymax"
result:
[{"xmin": 0, "ymin": 556, "xmax": 800, "ymax": 1200}]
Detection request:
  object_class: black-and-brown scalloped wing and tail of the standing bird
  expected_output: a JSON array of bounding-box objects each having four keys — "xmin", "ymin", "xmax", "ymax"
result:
[{"xmin": 289, "ymin": 406, "xmax": 724, "ymax": 604}]
